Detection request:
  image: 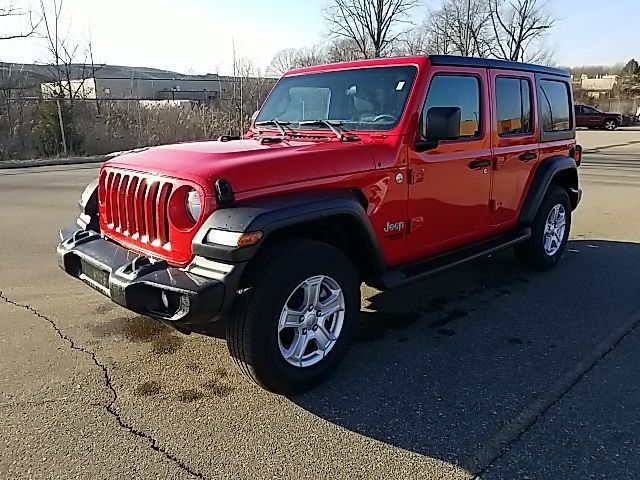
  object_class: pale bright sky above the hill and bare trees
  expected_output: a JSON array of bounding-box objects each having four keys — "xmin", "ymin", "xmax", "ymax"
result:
[{"xmin": 0, "ymin": 0, "xmax": 640, "ymax": 74}]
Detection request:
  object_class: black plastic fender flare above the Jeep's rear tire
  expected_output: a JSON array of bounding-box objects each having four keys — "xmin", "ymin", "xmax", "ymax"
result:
[{"xmin": 518, "ymin": 155, "xmax": 580, "ymax": 225}]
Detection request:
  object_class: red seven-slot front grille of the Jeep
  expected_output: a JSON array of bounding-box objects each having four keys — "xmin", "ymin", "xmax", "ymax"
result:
[{"xmin": 101, "ymin": 169, "xmax": 174, "ymax": 251}]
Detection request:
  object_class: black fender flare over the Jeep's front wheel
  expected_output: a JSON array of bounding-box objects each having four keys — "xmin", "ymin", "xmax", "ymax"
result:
[{"xmin": 192, "ymin": 190, "xmax": 385, "ymax": 271}]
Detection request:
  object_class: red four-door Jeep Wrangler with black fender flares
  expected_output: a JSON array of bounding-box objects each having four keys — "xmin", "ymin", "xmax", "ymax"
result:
[{"xmin": 57, "ymin": 56, "xmax": 581, "ymax": 393}]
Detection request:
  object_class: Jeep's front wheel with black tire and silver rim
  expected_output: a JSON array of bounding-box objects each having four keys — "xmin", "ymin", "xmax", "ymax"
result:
[{"xmin": 227, "ymin": 240, "xmax": 360, "ymax": 394}]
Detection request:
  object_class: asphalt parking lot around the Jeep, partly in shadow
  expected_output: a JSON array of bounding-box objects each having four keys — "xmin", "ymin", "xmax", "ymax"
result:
[{"xmin": 0, "ymin": 129, "xmax": 640, "ymax": 479}]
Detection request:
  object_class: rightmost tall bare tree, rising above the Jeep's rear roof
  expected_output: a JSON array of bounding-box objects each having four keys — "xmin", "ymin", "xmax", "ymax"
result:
[{"xmin": 488, "ymin": 0, "xmax": 557, "ymax": 62}]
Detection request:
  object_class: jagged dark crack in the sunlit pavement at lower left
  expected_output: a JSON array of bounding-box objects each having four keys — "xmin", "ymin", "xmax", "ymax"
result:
[{"xmin": 0, "ymin": 290, "xmax": 207, "ymax": 479}]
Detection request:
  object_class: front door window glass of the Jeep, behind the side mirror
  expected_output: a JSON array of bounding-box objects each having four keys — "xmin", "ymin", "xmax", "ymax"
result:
[{"xmin": 422, "ymin": 75, "xmax": 480, "ymax": 138}]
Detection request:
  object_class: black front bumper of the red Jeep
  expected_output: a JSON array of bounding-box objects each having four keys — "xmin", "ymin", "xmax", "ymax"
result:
[{"xmin": 57, "ymin": 225, "xmax": 244, "ymax": 334}]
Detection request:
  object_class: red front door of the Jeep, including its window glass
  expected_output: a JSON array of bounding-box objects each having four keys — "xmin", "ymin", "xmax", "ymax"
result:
[{"xmin": 408, "ymin": 67, "xmax": 492, "ymax": 253}]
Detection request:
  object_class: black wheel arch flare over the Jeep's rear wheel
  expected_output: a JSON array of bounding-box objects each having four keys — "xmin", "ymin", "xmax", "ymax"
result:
[{"xmin": 518, "ymin": 156, "xmax": 580, "ymax": 225}]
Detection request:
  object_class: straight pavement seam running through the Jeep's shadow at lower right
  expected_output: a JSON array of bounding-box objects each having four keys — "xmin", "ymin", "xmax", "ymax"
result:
[{"xmin": 472, "ymin": 312, "xmax": 640, "ymax": 480}]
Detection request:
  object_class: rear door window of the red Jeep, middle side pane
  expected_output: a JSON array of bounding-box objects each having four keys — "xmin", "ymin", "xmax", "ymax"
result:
[{"xmin": 496, "ymin": 77, "xmax": 532, "ymax": 136}]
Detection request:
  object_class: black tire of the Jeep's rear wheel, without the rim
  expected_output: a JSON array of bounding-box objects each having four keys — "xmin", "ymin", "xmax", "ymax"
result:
[{"xmin": 514, "ymin": 185, "xmax": 571, "ymax": 272}]
